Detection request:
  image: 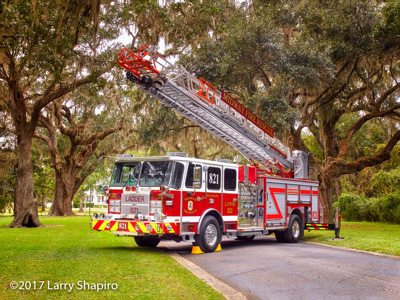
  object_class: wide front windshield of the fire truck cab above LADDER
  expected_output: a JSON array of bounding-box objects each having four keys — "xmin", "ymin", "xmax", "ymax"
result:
[{"xmin": 110, "ymin": 161, "xmax": 185, "ymax": 189}]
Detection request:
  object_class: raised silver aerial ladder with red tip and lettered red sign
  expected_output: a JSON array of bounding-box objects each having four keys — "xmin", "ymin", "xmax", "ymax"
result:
[{"xmin": 118, "ymin": 45, "xmax": 308, "ymax": 178}]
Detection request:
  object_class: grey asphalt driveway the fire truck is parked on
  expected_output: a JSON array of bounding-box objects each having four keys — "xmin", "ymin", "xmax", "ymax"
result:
[{"xmin": 159, "ymin": 236, "xmax": 400, "ymax": 300}]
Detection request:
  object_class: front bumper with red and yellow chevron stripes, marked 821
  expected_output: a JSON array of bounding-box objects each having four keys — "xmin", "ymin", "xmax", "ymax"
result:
[{"xmin": 90, "ymin": 220, "xmax": 178, "ymax": 235}]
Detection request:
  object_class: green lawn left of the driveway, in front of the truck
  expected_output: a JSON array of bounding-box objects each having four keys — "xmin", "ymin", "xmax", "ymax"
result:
[{"xmin": 0, "ymin": 216, "xmax": 223, "ymax": 299}]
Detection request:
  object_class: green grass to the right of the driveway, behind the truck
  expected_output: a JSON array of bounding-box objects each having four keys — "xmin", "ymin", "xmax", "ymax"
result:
[{"xmin": 303, "ymin": 222, "xmax": 400, "ymax": 256}]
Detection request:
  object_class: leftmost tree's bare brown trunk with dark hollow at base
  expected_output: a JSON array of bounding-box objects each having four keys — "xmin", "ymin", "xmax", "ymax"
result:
[{"xmin": 9, "ymin": 139, "xmax": 42, "ymax": 227}]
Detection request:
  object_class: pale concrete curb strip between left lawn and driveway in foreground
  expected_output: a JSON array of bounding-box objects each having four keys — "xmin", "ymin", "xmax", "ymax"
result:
[{"xmin": 168, "ymin": 252, "xmax": 247, "ymax": 300}]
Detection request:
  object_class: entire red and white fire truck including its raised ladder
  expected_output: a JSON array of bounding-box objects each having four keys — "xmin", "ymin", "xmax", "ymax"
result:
[{"xmin": 91, "ymin": 45, "xmax": 335, "ymax": 252}]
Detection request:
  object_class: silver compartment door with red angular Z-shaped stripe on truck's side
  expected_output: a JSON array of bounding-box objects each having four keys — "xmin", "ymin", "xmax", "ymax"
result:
[{"xmin": 265, "ymin": 183, "xmax": 286, "ymax": 226}]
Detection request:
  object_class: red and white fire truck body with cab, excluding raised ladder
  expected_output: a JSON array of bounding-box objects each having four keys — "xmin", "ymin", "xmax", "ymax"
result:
[{"xmin": 91, "ymin": 153, "xmax": 322, "ymax": 252}]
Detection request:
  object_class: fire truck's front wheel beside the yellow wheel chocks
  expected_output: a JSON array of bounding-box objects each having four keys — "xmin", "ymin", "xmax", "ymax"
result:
[{"xmin": 195, "ymin": 216, "xmax": 222, "ymax": 253}]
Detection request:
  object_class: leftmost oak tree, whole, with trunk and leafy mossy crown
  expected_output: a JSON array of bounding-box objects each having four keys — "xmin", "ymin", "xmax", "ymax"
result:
[{"xmin": 0, "ymin": 0, "xmax": 121, "ymax": 227}]
